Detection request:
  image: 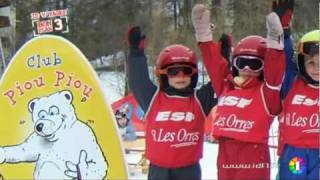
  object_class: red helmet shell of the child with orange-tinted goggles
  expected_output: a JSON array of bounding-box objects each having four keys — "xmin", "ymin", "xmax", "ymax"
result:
[{"xmin": 156, "ymin": 44, "xmax": 197, "ymax": 69}]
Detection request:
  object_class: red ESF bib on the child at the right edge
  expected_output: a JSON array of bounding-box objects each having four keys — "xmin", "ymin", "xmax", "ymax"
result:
[{"xmin": 280, "ymin": 78, "xmax": 320, "ymax": 148}]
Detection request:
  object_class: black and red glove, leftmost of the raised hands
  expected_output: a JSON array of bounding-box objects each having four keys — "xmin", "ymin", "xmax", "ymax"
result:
[{"xmin": 127, "ymin": 26, "xmax": 146, "ymax": 51}]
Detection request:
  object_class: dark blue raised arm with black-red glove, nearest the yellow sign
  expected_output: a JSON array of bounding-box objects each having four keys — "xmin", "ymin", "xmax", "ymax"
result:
[{"xmin": 127, "ymin": 26, "xmax": 157, "ymax": 112}]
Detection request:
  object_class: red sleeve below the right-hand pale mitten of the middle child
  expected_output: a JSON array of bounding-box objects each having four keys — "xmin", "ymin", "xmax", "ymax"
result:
[{"xmin": 263, "ymin": 49, "xmax": 286, "ymax": 115}]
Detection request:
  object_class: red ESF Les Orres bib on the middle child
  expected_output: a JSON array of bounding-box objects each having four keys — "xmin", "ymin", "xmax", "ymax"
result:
[{"xmin": 212, "ymin": 83, "xmax": 272, "ymax": 143}]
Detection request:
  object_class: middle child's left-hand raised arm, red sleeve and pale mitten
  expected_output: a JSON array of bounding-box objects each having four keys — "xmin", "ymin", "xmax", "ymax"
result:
[{"xmin": 192, "ymin": 4, "xmax": 231, "ymax": 96}]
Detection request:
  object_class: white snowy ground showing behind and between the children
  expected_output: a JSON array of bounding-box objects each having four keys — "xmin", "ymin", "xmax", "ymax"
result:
[{"xmin": 98, "ymin": 72, "xmax": 278, "ymax": 179}]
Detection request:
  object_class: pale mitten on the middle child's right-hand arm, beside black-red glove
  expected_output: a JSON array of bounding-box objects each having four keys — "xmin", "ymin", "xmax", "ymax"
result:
[{"xmin": 266, "ymin": 12, "xmax": 284, "ymax": 50}]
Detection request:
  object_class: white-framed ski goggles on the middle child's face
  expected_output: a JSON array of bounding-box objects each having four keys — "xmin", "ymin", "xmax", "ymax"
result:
[{"xmin": 233, "ymin": 56, "xmax": 264, "ymax": 72}]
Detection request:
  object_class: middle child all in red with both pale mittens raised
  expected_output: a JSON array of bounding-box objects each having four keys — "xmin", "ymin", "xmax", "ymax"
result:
[{"xmin": 192, "ymin": 4, "xmax": 285, "ymax": 179}]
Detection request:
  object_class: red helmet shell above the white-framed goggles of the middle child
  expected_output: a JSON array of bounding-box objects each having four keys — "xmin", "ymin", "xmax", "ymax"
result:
[{"xmin": 233, "ymin": 36, "xmax": 267, "ymax": 59}]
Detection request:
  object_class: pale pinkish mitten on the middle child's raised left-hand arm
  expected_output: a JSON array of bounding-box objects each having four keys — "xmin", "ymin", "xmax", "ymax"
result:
[{"xmin": 191, "ymin": 4, "xmax": 213, "ymax": 42}]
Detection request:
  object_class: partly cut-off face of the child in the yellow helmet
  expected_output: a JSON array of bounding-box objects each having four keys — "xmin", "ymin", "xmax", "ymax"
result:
[{"xmin": 304, "ymin": 54, "xmax": 319, "ymax": 81}]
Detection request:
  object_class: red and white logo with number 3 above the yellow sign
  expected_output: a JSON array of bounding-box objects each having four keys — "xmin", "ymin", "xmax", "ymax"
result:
[{"xmin": 30, "ymin": 9, "xmax": 69, "ymax": 36}]
